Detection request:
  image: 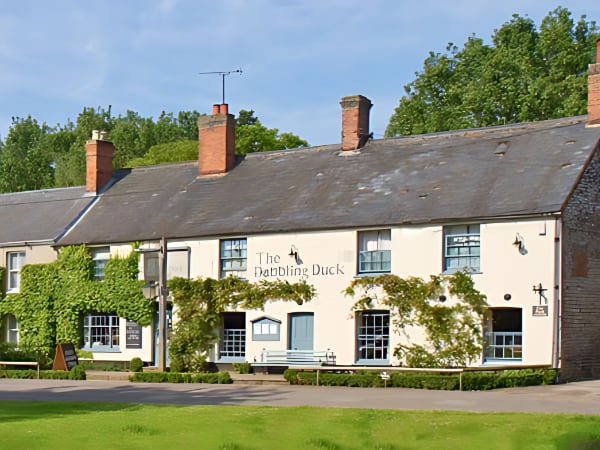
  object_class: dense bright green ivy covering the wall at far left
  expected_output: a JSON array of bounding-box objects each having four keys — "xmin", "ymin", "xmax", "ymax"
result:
[{"xmin": 0, "ymin": 245, "xmax": 154, "ymax": 355}]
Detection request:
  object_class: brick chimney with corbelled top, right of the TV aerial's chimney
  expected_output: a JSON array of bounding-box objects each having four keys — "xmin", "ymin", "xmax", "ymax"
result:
[{"xmin": 340, "ymin": 95, "xmax": 373, "ymax": 150}]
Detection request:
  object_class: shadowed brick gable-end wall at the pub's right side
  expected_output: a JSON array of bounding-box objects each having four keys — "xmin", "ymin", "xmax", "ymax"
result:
[{"xmin": 560, "ymin": 146, "xmax": 600, "ymax": 381}]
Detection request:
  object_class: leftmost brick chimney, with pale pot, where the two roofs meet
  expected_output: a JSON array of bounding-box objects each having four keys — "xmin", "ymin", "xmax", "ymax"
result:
[{"xmin": 85, "ymin": 130, "xmax": 115, "ymax": 193}]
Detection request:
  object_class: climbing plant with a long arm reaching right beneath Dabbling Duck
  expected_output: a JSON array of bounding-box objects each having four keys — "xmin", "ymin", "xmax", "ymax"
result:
[{"xmin": 169, "ymin": 277, "xmax": 315, "ymax": 371}]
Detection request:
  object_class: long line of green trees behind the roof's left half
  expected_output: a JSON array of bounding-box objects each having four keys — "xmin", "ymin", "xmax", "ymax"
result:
[{"xmin": 0, "ymin": 105, "xmax": 308, "ymax": 192}]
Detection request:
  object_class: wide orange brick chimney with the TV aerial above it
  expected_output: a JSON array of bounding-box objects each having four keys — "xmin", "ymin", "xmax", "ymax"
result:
[{"xmin": 198, "ymin": 104, "xmax": 235, "ymax": 175}]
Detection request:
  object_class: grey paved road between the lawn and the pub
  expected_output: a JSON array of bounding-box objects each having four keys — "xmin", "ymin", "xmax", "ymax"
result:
[{"xmin": 0, "ymin": 379, "xmax": 600, "ymax": 414}]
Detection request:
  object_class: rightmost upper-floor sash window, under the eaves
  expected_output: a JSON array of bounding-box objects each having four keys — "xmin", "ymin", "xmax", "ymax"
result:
[{"xmin": 444, "ymin": 225, "xmax": 479, "ymax": 272}]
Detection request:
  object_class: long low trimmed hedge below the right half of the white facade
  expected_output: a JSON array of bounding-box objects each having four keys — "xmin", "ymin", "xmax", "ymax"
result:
[{"xmin": 283, "ymin": 369, "xmax": 556, "ymax": 391}]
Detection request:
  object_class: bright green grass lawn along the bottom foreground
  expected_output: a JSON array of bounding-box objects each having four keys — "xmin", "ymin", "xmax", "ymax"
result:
[{"xmin": 0, "ymin": 401, "xmax": 600, "ymax": 450}]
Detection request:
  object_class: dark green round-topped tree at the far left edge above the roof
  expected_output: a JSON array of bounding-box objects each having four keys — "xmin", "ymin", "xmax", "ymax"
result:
[{"xmin": 0, "ymin": 116, "xmax": 54, "ymax": 192}]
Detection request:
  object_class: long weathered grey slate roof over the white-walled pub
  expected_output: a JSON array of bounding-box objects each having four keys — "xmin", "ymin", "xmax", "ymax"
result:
[{"xmin": 60, "ymin": 116, "xmax": 600, "ymax": 245}]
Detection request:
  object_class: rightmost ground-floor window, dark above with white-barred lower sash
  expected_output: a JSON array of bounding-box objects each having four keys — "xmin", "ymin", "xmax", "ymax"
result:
[{"xmin": 485, "ymin": 308, "xmax": 523, "ymax": 361}]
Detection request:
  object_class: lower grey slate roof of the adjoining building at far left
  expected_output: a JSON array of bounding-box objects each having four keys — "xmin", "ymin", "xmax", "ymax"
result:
[{"xmin": 0, "ymin": 186, "xmax": 94, "ymax": 246}]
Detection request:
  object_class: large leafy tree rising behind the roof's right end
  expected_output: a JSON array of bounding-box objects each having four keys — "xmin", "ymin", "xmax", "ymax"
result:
[{"xmin": 386, "ymin": 7, "xmax": 599, "ymax": 137}]
